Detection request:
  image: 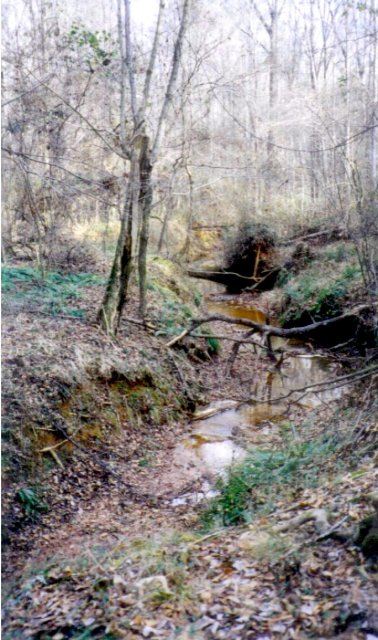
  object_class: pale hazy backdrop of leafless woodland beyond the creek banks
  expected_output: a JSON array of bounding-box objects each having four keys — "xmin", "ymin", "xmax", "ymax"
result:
[{"xmin": 2, "ymin": 0, "xmax": 378, "ymax": 325}]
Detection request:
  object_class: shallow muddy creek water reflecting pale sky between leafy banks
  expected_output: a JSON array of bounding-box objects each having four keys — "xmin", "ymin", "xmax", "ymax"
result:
[{"xmin": 156, "ymin": 297, "xmax": 345, "ymax": 507}]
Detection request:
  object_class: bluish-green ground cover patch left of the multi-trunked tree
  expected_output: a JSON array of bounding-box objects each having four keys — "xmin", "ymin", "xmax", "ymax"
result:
[{"xmin": 1, "ymin": 266, "xmax": 104, "ymax": 317}]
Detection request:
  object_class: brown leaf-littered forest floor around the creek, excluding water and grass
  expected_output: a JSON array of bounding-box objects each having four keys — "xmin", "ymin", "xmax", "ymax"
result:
[{"xmin": 3, "ymin": 258, "xmax": 378, "ymax": 640}]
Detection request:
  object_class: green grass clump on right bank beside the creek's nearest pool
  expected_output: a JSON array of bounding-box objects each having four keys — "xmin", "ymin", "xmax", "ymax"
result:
[{"xmin": 201, "ymin": 439, "xmax": 337, "ymax": 528}]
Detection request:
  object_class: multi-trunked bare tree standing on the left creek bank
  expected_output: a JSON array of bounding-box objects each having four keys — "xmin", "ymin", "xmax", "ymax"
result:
[{"xmin": 99, "ymin": 0, "xmax": 190, "ymax": 331}]
